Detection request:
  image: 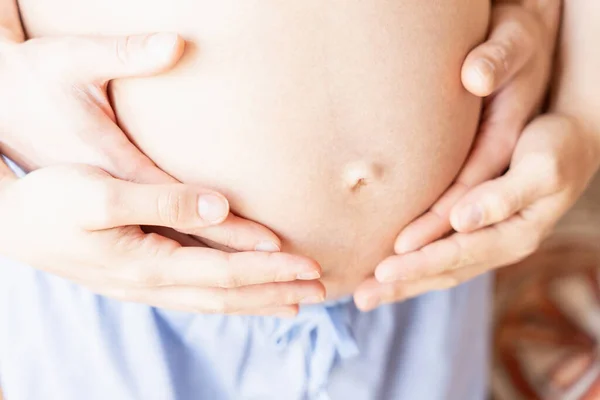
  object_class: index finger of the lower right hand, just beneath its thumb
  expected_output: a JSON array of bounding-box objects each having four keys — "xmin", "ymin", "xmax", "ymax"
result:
[{"xmin": 375, "ymin": 211, "xmax": 556, "ymax": 283}]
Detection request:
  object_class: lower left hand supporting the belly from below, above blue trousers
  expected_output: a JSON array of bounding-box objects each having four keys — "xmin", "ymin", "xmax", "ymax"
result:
[{"xmin": 0, "ymin": 159, "xmax": 324, "ymax": 316}]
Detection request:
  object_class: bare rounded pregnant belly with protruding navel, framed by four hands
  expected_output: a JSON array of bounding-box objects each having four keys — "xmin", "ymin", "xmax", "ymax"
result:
[{"xmin": 20, "ymin": 0, "xmax": 489, "ymax": 298}]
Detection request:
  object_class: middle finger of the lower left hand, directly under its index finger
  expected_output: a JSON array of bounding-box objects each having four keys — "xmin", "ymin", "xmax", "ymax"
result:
[{"xmin": 104, "ymin": 281, "xmax": 325, "ymax": 314}]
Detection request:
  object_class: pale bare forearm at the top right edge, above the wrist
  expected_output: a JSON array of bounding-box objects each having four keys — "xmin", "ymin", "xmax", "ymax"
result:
[{"xmin": 552, "ymin": 0, "xmax": 600, "ymax": 138}]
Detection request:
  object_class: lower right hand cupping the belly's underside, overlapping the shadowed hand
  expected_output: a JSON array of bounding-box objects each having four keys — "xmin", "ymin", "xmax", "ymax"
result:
[{"xmin": 360, "ymin": 114, "xmax": 600, "ymax": 310}]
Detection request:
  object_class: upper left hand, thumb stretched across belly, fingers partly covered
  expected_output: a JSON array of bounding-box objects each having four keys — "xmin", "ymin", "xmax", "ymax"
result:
[{"xmin": 0, "ymin": 33, "xmax": 281, "ymax": 251}]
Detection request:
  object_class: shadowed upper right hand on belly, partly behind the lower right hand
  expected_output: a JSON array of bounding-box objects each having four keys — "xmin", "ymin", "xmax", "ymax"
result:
[{"xmin": 395, "ymin": 0, "xmax": 560, "ymax": 254}]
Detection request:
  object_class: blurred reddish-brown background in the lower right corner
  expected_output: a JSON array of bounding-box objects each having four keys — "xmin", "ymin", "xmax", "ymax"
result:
[{"xmin": 492, "ymin": 176, "xmax": 600, "ymax": 400}]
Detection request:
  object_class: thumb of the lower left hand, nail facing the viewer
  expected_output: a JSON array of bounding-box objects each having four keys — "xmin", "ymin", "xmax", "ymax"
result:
[{"xmin": 84, "ymin": 177, "xmax": 229, "ymax": 231}]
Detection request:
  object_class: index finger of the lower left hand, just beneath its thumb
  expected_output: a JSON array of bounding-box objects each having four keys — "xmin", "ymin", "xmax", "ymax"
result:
[{"xmin": 110, "ymin": 239, "xmax": 321, "ymax": 288}]
